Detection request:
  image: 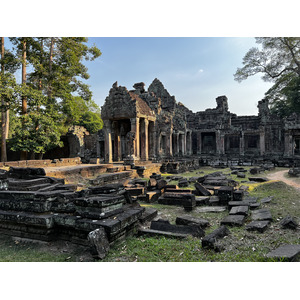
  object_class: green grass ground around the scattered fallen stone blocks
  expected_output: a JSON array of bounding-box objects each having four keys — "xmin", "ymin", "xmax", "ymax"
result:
[{"xmin": 0, "ymin": 168, "xmax": 300, "ymax": 262}]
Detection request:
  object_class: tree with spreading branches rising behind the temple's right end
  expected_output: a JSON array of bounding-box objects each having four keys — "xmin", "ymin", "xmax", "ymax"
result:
[{"xmin": 234, "ymin": 37, "xmax": 300, "ymax": 116}]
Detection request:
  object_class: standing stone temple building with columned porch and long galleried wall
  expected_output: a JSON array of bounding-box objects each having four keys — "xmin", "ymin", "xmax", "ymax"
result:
[{"xmin": 100, "ymin": 79, "xmax": 300, "ymax": 164}]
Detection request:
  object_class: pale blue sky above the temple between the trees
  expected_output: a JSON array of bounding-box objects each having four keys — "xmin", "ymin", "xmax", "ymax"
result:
[{"xmin": 83, "ymin": 37, "xmax": 271, "ymax": 115}]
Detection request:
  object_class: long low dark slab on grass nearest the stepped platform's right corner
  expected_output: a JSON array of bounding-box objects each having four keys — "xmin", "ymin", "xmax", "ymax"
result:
[{"xmin": 150, "ymin": 219, "xmax": 205, "ymax": 238}]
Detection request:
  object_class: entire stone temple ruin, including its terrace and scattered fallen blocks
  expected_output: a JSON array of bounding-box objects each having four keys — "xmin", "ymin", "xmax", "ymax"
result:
[{"xmin": 0, "ymin": 79, "xmax": 300, "ymax": 260}]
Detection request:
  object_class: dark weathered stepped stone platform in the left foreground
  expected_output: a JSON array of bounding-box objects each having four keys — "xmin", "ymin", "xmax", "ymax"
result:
[{"xmin": 0, "ymin": 168, "xmax": 157, "ymax": 258}]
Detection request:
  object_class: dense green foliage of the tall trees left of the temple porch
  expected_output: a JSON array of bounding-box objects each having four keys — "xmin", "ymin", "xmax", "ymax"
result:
[{"xmin": 0, "ymin": 37, "xmax": 103, "ymax": 161}]
